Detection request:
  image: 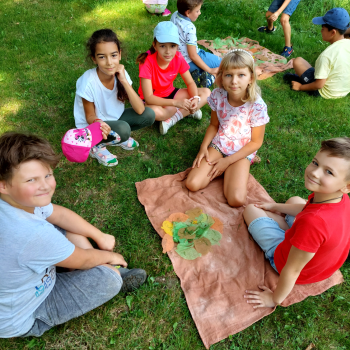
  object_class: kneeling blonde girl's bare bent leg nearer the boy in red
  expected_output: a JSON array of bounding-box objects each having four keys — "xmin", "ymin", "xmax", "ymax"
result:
[{"xmin": 224, "ymin": 158, "xmax": 250, "ymax": 207}]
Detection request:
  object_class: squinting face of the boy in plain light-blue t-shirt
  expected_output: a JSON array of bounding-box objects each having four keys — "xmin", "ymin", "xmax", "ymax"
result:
[{"xmin": 0, "ymin": 160, "xmax": 56, "ymax": 213}]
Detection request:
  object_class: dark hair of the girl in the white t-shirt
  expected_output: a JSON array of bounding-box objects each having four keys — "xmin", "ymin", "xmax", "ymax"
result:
[{"xmin": 86, "ymin": 29, "xmax": 129, "ymax": 103}]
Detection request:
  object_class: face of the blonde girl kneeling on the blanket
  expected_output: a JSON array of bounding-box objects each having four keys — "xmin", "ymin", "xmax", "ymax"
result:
[{"xmin": 222, "ymin": 67, "xmax": 253, "ymax": 99}]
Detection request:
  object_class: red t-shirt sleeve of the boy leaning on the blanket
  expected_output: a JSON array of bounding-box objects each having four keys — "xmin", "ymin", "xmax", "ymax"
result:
[{"xmin": 290, "ymin": 214, "xmax": 328, "ymax": 253}]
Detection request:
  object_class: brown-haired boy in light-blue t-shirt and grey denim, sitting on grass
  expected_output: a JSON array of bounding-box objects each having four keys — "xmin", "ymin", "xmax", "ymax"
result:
[{"xmin": 0, "ymin": 132, "xmax": 146, "ymax": 338}]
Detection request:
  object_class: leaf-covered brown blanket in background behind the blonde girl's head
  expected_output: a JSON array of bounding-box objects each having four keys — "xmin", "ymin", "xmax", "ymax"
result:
[{"xmin": 197, "ymin": 36, "xmax": 293, "ymax": 80}]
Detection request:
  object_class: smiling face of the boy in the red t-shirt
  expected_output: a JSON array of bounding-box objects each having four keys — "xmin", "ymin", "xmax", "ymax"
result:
[{"xmin": 305, "ymin": 151, "xmax": 350, "ymax": 194}]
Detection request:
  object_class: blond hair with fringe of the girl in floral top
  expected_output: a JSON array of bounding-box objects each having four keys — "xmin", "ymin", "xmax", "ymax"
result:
[{"xmin": 215, "ymin": 50, "xmax": 261, "ymax": 102}]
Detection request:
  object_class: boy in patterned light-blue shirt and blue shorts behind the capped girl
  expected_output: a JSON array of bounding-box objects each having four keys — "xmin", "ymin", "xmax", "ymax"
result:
[{"xmin": 170, "ymin": 0, "xmax": 221, "ymax": 84}]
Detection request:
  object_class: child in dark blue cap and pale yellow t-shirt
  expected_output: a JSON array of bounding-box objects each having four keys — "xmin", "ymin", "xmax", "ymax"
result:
[{"xmin": 283, "ymin": 8, "xmax": 350, "ymax": 99}]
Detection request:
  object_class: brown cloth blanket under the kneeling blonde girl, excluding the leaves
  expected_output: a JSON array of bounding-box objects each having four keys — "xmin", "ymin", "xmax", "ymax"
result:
[{"xmin": 136, "ymin": 169, "xmax": 343, "ymax": 349}]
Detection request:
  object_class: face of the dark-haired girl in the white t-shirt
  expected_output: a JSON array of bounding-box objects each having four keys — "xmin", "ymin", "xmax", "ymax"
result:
[{"xmin": 92, "ymin": 41, "xmax": 121, "ymax": 76}]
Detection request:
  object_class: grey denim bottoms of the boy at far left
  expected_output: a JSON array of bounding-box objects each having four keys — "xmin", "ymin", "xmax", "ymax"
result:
[{"xmin": 22, "ymin": 227, "xmax": 123, "ymax": 337}]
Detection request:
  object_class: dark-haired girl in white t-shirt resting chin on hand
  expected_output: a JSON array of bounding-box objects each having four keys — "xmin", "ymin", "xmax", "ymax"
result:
[{"xmin": 74, "ymin": 29, "xmax": 155, "ymax": 166}]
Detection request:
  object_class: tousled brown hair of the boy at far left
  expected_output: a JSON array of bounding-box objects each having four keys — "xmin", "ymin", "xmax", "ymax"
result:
[{"xmin": 0, "ymin": 132, "xmax": 59, "ymax": 182}]
